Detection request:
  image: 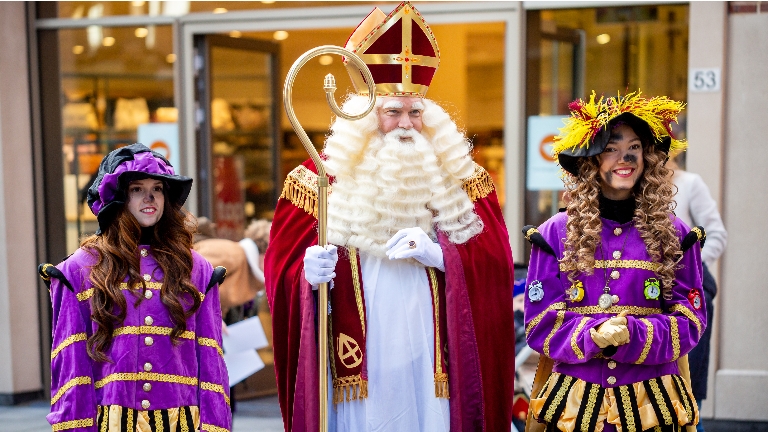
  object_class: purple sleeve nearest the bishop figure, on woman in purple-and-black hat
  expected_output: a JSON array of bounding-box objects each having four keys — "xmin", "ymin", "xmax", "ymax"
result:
[{"xmin": 193, "ymin": 252, "xmax": 232, "ymax": 432}]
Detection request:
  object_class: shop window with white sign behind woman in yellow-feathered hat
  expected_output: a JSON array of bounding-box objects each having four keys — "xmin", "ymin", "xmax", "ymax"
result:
[{"xmin": 525, "ymin": 5, "xmax": 688, "ymax": 264}]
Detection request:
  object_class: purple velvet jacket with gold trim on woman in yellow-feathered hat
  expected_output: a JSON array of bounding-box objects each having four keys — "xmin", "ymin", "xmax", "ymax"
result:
[{"xmin": 525, "ymin": 212, "xmax": 707, "ymax": 387}]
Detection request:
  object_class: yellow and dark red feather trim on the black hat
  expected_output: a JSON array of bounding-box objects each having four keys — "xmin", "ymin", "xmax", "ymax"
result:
[{"xmin": 552, "ymin": 90, "xmax": 688, "ymax": 161}]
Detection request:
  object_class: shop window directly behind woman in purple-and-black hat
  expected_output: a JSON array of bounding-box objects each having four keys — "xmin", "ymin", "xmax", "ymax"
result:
[{"xmin": 58, "ymin": 26, "xmax": 179, "ymax": 253}]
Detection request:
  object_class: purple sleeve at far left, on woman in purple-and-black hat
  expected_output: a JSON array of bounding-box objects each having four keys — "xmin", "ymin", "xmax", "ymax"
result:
[{"xmin": 46, "ymin": 254, "xmax": 97, "ymax": 432}]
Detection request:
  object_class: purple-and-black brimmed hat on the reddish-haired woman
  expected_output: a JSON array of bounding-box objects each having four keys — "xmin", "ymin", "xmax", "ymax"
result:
[{"xmin": 88, "ymin": 143, "xmax": 192, "ymax": 234}]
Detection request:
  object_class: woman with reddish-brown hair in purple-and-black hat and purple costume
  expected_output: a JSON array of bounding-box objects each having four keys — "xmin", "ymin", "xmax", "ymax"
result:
[{"xmin": 39, "ymin": 144, "xmax": 232, "ymax": 432}]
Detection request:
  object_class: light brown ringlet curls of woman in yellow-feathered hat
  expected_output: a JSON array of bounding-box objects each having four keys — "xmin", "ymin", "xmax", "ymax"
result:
[{"xmin": 561, "ymin": 142, "xmax": 682, "ymax": 300}]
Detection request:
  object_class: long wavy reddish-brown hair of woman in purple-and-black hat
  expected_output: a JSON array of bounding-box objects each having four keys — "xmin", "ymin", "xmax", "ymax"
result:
[{"xmin": 80, "ymin": 188, "xmax": 201, "ymax": 361}]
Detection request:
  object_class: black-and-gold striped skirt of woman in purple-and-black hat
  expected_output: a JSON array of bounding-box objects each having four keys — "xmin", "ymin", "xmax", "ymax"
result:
[{"xmin": 96, "ymin": 405, "xmax": 200, "ymax": 432}]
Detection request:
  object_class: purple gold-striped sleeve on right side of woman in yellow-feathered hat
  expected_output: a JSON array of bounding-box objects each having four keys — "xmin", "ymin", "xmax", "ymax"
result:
[{"xmin": 611, "ymin": 222, "xmax": 707, "ymax": 364}]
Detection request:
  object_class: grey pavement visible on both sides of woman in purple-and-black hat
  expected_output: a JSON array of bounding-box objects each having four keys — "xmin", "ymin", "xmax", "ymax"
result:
[{"xmin": 0, "ymin": 396, "xmax": 283, "ymax": 432}]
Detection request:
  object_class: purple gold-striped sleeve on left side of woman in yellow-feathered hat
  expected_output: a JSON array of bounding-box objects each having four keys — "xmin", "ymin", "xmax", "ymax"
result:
[{"xmin": 525, "ymin": 218, "xmax": 606, "ymax": 363}]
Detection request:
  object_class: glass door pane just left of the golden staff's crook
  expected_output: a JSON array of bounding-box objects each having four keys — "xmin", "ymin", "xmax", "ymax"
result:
[{"xmin": 195, "ymin": 35, "xmax": 282, "ymax": 241}]
